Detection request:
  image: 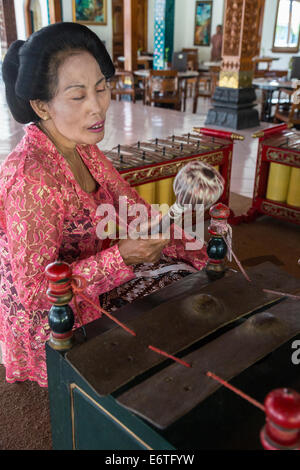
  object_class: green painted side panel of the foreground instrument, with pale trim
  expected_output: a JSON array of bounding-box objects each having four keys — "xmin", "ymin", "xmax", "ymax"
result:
[{"xmin": 46, "ymin": 344, "xmax": 174, "ymax": 450}]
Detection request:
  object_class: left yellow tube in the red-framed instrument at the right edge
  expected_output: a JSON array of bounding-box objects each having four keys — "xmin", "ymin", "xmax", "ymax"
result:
[{"xmin": 266, "ymin": 163, "xmax": 291, "ymax": 202}]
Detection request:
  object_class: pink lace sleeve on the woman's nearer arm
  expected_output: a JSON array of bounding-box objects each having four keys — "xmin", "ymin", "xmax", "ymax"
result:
[{"xmin": 5, "ymin": 175, "xmax": 134, "ymax": 310}]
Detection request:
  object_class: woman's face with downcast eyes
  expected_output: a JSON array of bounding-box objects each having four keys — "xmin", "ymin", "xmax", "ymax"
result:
[{"xmin": 45, "ymin": 51, "xmax": 110, "ymax": 147}]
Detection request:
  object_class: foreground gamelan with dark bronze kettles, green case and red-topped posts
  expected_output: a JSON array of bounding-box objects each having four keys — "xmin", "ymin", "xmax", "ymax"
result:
[{"xmin": 46, "ymin": 241, "xmax": 300, "ymax": 450}]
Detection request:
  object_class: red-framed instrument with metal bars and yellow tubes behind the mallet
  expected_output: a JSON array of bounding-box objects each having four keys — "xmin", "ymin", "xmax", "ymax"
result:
[{"xmin": 104, "ymin": 127, "xmax": 244, "ymax": 210}]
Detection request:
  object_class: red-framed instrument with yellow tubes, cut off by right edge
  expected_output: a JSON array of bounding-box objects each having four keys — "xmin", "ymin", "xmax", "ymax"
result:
[{"xmin": 231, "ymin": 124, "xmax": 300, "ymax": 224}]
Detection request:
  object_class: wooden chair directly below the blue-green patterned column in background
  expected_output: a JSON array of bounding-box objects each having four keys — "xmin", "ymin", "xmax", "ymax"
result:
[{"xmin": 146, "ymin": 70, "xmax": 182, "ymax": 111}]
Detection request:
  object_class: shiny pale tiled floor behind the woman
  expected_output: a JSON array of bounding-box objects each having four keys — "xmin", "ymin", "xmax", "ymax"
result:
[{"xmin": 0, "ymin": 81, "xmax": 269, "ymax": 197}]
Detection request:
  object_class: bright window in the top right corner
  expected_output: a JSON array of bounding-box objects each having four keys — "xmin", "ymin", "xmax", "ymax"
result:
[{"xmin": 272, "ymin": 0, "xmax": 300, "ymax": 52}]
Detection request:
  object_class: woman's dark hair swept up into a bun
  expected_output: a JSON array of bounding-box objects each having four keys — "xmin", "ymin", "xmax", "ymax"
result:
[{"xmin": 2, "ymin": 22, "xmax": 115, "ymax": 124}]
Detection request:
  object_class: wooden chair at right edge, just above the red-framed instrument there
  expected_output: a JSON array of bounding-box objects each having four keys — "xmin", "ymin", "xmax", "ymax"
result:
[{"xmin": 274, "ymin": 87, "xmax": 300, "ymax": 126}]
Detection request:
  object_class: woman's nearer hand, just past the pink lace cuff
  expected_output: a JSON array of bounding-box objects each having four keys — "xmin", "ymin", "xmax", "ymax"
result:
[{"xmin": 118, "ymin": 238, "xmax": 170, "ymax": 266}]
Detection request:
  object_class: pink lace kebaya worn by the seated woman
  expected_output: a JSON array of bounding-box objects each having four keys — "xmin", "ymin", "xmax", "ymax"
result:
[{"xmin": 0, "ymin": 124, "xmax": 207, "ymax": 387}]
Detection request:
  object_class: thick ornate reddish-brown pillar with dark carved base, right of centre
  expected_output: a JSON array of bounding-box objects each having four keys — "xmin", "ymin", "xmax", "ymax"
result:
[{"xmin": 205, "ymin": 0, "xmax": 264, "ymax": 129}]
